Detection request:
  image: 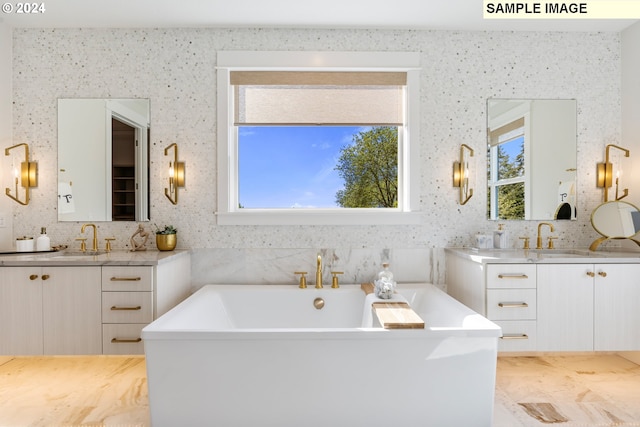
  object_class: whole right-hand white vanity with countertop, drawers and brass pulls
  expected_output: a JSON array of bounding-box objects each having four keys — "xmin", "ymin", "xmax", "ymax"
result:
[{"xmin": 446, "ymin": 249, "xmax": 640, "ymax": 351}]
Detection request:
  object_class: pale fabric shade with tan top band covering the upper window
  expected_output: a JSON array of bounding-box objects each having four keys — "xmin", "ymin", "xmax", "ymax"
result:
[{"xmin": 231, "ymin": 71, "xmax": 406, "ymax": 126}]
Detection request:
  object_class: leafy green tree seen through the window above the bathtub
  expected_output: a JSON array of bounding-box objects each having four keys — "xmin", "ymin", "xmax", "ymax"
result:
[{"xmin": 335, "ymin": 126, "xmax": 398, "ymax": 208}]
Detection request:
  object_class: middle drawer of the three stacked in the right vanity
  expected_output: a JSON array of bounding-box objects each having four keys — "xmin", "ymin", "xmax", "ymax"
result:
[{"xmin": 487, "ymin": 289, "xmax": 536, "ymax": 320}]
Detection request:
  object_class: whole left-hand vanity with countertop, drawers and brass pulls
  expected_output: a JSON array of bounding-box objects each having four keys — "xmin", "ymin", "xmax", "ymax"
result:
[{"xmin": 0, "ymin": 251, "xmax": 191, "ymax": 355}]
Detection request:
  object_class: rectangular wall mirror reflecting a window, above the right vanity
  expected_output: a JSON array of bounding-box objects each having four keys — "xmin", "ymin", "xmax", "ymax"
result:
[{"xmin": 487, "ymin": 99, "xmax": 577, "ymax": 221}]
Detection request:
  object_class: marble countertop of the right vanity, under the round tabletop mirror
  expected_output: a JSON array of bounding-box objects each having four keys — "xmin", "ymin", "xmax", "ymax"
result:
[{"xmin": 445, "ymin": 248, "xmax": 640, "ymax": 264}]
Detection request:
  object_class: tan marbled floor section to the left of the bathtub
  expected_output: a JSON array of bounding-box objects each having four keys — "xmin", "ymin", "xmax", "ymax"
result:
[{"xmin": 0, "ymin": 356, "xmax": 150, "ymax": 427}]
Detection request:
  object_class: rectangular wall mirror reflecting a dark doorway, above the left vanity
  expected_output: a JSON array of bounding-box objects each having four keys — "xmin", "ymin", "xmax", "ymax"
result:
[{"xmin": 58, "ymin": 99, "xmax": 150, "ymax": 221}]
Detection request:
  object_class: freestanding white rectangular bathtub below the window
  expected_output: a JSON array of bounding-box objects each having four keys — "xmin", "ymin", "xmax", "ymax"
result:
[{"xmin": 142, "ymin": 284, "xmax": 501, "ymax": 427}]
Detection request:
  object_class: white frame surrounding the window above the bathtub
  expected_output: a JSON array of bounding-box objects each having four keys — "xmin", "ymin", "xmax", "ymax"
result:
[{"xmin": 216, "ymin": 51, "xmax": 420, "ymax": 225}]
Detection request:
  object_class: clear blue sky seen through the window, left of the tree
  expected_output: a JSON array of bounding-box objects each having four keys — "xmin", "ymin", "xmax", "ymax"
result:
[{"xmin": 238, "ymin": 126, "xmax": 366, "ymax": 208}]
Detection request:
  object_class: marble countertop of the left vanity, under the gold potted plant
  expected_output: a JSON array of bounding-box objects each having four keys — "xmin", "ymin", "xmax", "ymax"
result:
[{"xmin": 0, "ymin": 249, "xmax": 189, "ymax": 267}]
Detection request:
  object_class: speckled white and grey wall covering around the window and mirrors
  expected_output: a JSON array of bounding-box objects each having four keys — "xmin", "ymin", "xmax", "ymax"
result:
[{"xmin": 8, "ymin": 28, "xmax": 621, "ymax": 288}]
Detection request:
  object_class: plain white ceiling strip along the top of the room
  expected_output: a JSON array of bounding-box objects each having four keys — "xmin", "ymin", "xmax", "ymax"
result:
[{"xmin": 0, "ymin": 0, "xmax": 638, "ymax": 32}]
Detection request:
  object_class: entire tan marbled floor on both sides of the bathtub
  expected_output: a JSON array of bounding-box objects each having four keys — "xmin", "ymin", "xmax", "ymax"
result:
[{"xmin": 0, "ymin": 355, "xmax": 640, "ymax": 427}]
